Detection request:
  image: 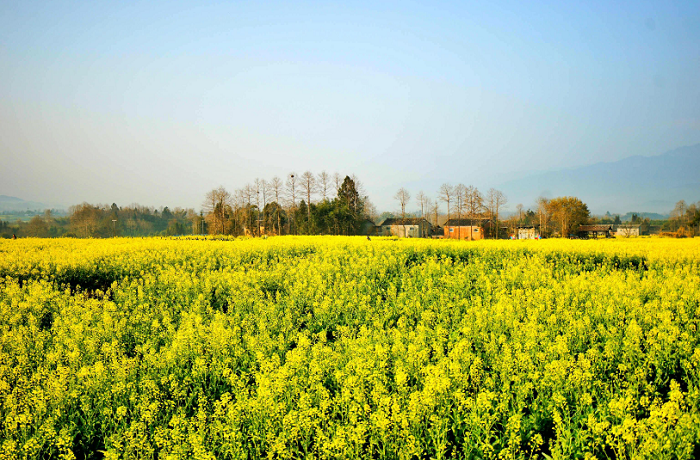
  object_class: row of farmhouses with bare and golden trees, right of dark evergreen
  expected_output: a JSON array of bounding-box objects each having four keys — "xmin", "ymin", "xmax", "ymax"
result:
[{"xmin": 372, "ymin": 190, "xmax": 700, "ymax": 241}]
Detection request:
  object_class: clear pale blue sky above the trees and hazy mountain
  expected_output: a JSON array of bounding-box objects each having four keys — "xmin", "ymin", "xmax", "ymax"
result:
[{"xmin": 0, "ymin": 0, "xmax": 700, "ymax": 211}]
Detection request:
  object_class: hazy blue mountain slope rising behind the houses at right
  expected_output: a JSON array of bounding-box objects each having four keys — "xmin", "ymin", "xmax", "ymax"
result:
[{"xmin": 500, "ymin": 144, "xmax": 700, "ymax": 214}]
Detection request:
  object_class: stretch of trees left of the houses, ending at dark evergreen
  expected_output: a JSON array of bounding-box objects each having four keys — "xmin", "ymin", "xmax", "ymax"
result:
[{"xmin": 0, "ymin": 171, "xmax": 376, "ymax": 238}]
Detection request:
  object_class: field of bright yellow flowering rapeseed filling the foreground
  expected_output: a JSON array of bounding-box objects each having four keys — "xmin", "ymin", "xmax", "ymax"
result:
[{"xmin": 0, "ymin": 237, "xmax": 700, "ymax": 459}]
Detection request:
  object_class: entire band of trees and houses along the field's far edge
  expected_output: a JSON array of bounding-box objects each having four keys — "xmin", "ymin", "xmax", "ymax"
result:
[{"xmin": 0, "ymin": 172, "xmax": 700, "ymax": 241}]
